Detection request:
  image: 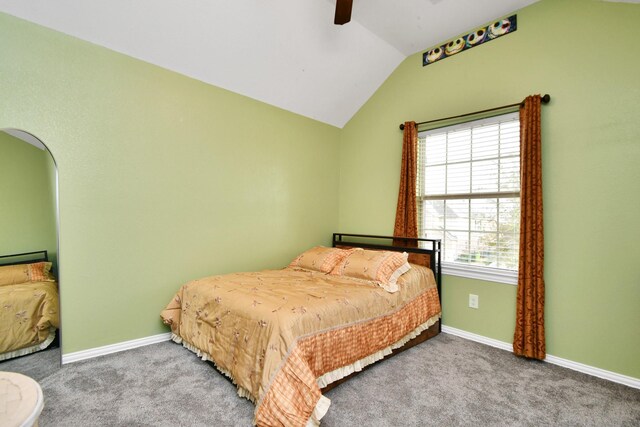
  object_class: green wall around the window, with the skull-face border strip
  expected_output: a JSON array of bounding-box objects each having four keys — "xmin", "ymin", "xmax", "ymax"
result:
[{"xmin": 339, "ymin": 0, "xmax": 640, "ymax": 378}]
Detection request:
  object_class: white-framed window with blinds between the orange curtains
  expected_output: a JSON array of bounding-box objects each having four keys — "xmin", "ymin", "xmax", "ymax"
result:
[{"xmin": 418, "ymin": 113, "xmax": 520, "ymax": 283}]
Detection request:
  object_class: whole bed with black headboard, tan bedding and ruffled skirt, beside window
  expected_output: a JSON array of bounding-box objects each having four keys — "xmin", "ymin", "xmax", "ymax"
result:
[{"xmin": 161, "ymin": 233, "xmax": 441, "ymax": 427}]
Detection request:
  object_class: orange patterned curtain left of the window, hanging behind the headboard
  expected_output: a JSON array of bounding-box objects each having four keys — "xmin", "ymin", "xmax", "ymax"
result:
[{"xmin": 393, "ymin": 122, "xmax": 418, "ymax": 247}]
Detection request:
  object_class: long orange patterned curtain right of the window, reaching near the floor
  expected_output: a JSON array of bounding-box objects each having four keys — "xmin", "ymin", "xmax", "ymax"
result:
[{"xmin": 513, "ymin": 95, "xmax": 546, "ymax": 360}]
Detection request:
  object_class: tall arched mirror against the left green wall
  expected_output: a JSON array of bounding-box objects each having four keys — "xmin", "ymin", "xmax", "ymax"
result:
[{"xmin": 0, "ymin": 129, "xmax": 61, "ymax": 377}]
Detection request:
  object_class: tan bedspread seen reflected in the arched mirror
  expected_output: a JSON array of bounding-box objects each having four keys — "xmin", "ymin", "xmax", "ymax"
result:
[{"xmin": 0, "ymin": 282, "xmax": 59, "ymax": 354}]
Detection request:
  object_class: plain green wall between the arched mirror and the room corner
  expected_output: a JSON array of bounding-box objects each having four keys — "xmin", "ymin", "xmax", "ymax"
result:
[{"xmin": 0, "ymin": 14, "xmax": 340, "ymax": 353}]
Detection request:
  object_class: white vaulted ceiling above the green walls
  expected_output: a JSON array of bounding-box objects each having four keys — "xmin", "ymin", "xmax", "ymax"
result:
[{"xmin": 0, "ymin": 0, "xmax": 538, "ymax": 127}]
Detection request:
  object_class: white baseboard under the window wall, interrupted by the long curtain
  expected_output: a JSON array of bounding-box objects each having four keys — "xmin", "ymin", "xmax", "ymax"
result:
[{"xmin": 442, "ymin": 325, "xmax": 640, "ymax": 389}]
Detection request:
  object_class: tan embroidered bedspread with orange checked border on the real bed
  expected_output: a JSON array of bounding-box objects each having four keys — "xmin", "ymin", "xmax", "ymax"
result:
[{"xmin": 161, "ymin": 266, "xmax": 440, "ymax": 426}]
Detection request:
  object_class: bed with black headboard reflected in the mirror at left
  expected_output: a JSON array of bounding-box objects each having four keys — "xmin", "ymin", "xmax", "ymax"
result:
[{"xmin": 0, "ymin": 251, "xmax": 59, "ymax": 361}]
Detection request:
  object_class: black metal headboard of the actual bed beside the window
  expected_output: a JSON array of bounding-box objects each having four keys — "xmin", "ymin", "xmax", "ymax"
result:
[{"xmin": 332, "ymin": 233, "xmax": 442, "ymax": 300}]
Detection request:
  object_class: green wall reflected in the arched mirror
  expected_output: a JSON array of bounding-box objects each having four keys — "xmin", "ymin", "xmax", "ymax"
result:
[{"xmin": 0, "ymin": 132, "xmax": 57, "ymax": 270}]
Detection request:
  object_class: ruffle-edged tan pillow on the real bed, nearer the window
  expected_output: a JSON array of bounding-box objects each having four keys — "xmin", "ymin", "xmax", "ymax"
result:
[{"xmin": 331, "ymin": 250, "xmax": 411, "ymax": 292}]
